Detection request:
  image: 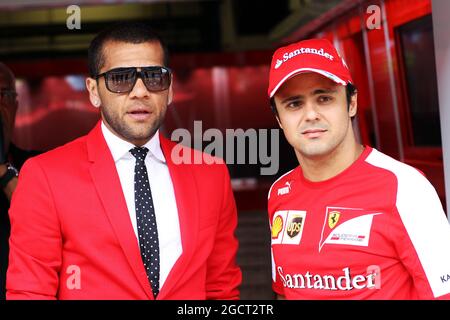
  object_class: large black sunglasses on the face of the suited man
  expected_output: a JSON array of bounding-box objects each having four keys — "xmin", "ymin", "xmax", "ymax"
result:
[{"xmin": 95, "ymin": 66, "xmax": 172, "ymax": 93}]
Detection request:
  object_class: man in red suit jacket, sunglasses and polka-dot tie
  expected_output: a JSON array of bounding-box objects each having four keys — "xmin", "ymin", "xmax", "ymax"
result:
[{"xmin": 7, "ymin": 23, "xmax": 241, "ymax": 299}]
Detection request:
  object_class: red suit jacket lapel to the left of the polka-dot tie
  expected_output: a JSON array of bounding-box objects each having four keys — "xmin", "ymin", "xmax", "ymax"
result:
[{"xmin": 87, "ymin": 122, "xmax": 153, "ymax": 299}]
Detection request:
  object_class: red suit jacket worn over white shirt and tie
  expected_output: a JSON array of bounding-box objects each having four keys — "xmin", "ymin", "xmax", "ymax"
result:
[{"xmin": 7, "ymin": 123, "xmax": 241, "ymax": 299}]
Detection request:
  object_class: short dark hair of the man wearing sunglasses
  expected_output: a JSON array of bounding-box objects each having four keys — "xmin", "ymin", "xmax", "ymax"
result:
[{"xmin": 88, "ymin": 22, "xmax": 169, "ymax": 77}]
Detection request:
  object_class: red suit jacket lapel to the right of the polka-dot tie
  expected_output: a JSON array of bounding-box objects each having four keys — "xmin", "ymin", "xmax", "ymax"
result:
[{"xmin": 158, "ymin": 134, "xmax": 199, "ymax": 299}]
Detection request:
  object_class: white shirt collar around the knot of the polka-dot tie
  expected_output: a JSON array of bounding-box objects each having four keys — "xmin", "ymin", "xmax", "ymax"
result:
[{"xmin": 101, "ymin": 121, "xmax": 166, "ymax": 163}]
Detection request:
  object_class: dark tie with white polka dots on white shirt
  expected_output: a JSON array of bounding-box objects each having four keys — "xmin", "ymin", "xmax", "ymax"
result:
[{"xmin": 130, "ymin": 147, "xmax": 159, "ymax": 298}]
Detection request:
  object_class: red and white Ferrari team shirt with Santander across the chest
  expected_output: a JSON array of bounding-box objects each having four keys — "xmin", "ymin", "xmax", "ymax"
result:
[{"xmin": 268, "ymin": 147, "xmax": 450, "ymax": 299}]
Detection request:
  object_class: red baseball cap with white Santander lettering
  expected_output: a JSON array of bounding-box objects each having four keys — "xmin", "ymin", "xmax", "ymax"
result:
[{"xmin": 267, "ymin": 39, "xmax": 353, "ymax": 98}]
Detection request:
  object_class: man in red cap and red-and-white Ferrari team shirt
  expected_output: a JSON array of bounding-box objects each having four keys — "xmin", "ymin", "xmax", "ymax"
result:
[{"xmin": 268, "ymin": 39, "xmax": 450, "ymax": 299}]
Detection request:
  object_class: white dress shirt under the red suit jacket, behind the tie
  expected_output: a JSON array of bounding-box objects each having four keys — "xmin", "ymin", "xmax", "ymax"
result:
[{"xmin": 101, "ymin": 121, "xmax": 183, "ymax": 288}]
